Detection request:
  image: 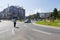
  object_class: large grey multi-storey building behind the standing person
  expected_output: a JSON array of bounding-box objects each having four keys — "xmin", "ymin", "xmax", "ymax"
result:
[{"xmin": 0, "ymin": 6, "xmax": 25, "ymax": 20}]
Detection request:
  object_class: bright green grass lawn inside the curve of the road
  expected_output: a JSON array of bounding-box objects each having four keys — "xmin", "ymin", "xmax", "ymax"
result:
[{"xmin": 36, "ymin": 20, "xmax": 60, "ymax": 27}]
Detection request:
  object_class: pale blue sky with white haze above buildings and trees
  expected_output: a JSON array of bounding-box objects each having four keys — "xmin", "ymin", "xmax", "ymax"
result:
[{"xmin": 0, "ymin": 0, "xmax": 60, "ymax": 16}]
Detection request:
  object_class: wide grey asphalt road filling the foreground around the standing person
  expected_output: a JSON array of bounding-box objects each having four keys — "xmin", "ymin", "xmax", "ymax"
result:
[{"xmin": 0, "ymin": 20, "xmax": 60, "ymax": 40}]
